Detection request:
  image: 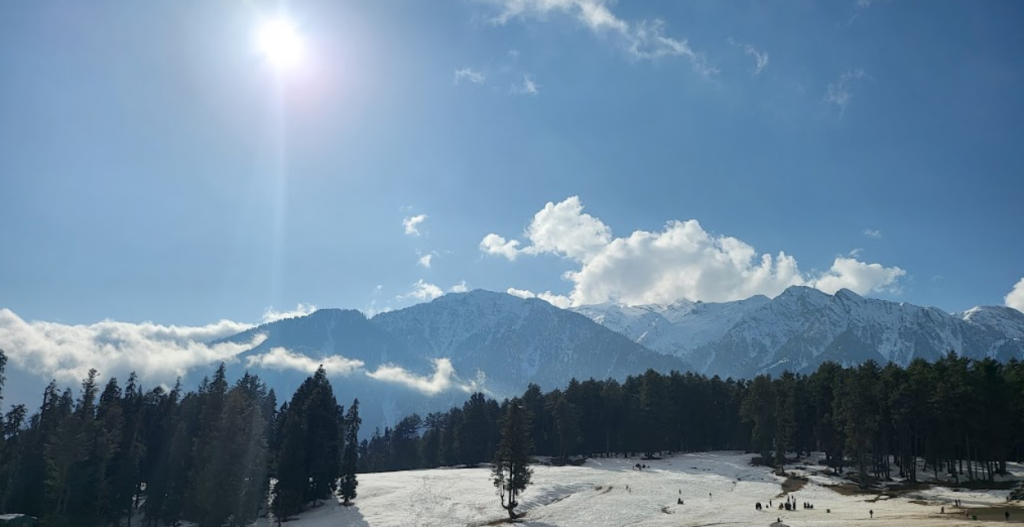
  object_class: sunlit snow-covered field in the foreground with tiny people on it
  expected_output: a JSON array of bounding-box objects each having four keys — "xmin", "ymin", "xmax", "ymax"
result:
[{"xmin": 266, "ymin": 452, "xmax": 1024, "ymax": 527}]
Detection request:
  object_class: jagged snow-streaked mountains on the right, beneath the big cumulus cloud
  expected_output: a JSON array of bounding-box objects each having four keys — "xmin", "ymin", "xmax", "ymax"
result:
[{"xmin": 573, "ymin": 287, "xmax": 1024, "ymax": 377}]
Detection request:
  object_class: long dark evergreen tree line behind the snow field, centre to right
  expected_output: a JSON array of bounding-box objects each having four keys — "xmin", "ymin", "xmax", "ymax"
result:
[{"xmin": 359, "ymin": 353, "xmax": 1024, "ymax": 491}]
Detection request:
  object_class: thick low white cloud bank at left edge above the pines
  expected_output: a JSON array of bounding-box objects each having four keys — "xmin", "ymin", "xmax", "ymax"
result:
[{"xmin": 0, "ymin": 309, "xmax": 265, "ymax": 384}]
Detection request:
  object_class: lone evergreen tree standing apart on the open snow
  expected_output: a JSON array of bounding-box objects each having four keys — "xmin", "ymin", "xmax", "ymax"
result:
[{"xmin": 494, "ymin": 398, "xmax": 534, "ymax": 520}]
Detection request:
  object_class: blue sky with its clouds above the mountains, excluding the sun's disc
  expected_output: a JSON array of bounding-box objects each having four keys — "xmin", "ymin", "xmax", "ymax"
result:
[{"xmin": 0, "ymin": 0, "xmax": 1024, "ymax": 324}]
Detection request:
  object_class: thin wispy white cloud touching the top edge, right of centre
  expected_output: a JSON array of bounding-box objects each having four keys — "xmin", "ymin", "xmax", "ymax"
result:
[{"xmin": 483, "ymin": 0, "xmax": 718, "ymax": 77}]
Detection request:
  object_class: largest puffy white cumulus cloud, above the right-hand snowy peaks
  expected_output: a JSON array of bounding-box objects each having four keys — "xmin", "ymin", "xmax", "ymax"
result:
[{"xmin": 480, "ymin": 196, "xmax": 905, "ymax": 306}]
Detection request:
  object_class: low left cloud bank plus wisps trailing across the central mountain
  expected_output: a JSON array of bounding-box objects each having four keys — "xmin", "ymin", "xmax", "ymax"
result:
[{"xmin": 0, "ymin": 302, "xmax": 483, "ymax": 395}]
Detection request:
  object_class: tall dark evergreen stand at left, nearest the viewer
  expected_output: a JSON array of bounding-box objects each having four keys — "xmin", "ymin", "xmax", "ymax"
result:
[{"xmin": 0, "ymin": 351, "xmax": 359, "ymax": 527}]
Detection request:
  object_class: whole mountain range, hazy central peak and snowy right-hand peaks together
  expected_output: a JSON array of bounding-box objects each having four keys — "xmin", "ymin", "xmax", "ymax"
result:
[{"xmin": 8, "ymin": 287, "xmax": 1024, "ymax": 432}]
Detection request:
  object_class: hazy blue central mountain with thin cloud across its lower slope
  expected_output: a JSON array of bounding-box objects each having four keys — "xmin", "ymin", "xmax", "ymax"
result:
[{"xmin": 226, "ymin": 291, "xmax": 689, "ymax": 431}]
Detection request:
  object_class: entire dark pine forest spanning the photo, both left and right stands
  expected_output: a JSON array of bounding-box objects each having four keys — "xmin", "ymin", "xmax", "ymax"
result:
[{"xmin": 0, "ymin": 352, "xmax": 1024, "ymax": 527}]
